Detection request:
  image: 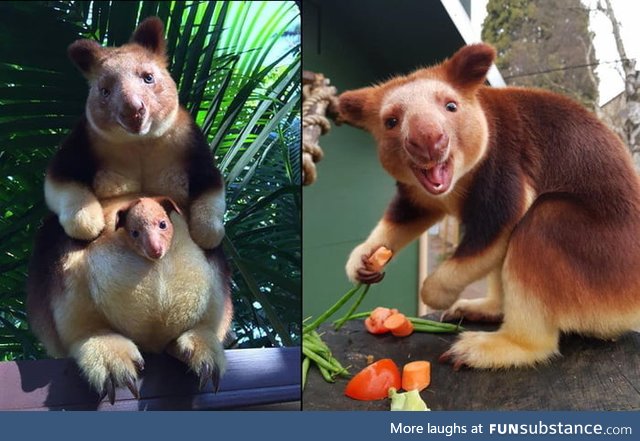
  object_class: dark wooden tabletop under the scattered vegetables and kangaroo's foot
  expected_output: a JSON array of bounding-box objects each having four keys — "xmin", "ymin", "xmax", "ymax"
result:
[{"xmin": 302, "ymin": 320, "xmax": 640, "ymax": 410}]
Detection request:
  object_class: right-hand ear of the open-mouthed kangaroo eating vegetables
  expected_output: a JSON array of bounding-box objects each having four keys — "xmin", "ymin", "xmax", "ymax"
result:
[{"xmin": 443, "ymin": 43, "xmax": 496, "ymax": 87}]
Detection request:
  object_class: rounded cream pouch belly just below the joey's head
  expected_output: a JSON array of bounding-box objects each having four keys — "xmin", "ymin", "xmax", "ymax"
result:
[{"xmin": 87, "ymin": 220, "xmax": 212, "ymax": 352}]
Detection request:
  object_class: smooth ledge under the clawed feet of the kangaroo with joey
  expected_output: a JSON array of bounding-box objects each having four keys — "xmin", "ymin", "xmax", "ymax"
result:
[{"xmin": 0, "ymin": 347, "xmax": 300, "ymax": 410}]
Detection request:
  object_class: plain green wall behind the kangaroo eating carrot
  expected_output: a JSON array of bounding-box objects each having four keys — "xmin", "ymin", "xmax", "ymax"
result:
[{"xmin": 303, "ymin": 4, "xmax": 418, "ymax": 317}]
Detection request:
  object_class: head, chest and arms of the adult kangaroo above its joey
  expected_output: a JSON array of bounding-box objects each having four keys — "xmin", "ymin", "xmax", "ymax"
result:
[{"xmin": 45, "ymin": 18, "xmax": 225, "ymax": 249}]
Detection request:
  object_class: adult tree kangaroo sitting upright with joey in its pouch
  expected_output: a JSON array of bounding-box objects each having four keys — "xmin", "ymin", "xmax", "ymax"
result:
[{"xmin": 27, "ymin": 17, "xmax": 231, "ymax": 401}]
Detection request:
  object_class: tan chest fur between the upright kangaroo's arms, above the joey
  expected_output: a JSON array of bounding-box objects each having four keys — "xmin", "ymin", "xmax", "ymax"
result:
[{"xmin": 93, "ymin": 134, "xmax": 189, "ymax": 206}]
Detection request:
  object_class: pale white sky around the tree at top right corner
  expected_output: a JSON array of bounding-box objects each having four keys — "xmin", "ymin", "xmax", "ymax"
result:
[{"xmin": 471, "ymin": 0, "xmax": 640, "ymax": 105}]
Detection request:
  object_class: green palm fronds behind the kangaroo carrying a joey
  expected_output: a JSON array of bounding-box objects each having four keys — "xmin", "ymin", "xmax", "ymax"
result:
[{"xmin": 0, "ymin": 1, "xmax": 301, "ymax": 360}]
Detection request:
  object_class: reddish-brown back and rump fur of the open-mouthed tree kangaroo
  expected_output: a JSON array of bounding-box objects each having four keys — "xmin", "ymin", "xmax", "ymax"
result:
[{"xmin": 480, "ymin": 88, "xmax": 640, "ymax": 313}]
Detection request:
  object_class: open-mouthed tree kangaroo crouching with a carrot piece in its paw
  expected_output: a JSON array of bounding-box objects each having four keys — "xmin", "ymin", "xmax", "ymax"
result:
[{"xmin": 340, "ymin": 44, "xmax": 640, "ymax": 368}]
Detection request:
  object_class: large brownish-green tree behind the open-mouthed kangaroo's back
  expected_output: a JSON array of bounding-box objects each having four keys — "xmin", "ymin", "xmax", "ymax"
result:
[{"xmin": 482, "ymin": 0, "xmax": 598, "ymax": 109}]
